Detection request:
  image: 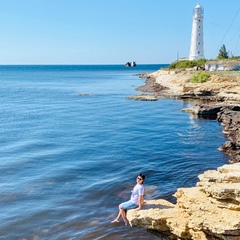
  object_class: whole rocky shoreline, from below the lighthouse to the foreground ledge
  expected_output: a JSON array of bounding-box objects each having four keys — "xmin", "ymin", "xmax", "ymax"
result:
[{"xmin": 127, "ymin": 70, "xmax": 240, "ymax": 240}]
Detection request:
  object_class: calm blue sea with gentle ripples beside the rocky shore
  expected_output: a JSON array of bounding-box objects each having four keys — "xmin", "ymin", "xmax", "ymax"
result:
[{"xmin": 0, "ymin": 65, "xmax": 228, "ymax": 240}]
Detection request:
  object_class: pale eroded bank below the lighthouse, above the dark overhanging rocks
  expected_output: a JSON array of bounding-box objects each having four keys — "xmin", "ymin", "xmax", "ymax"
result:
[{"xmin": 128, "ymin": 69, "xmax": 240, "ymax": 102}]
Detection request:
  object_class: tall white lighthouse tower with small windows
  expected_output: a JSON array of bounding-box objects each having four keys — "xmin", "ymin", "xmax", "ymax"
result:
[{"xmin": 189, "ymin": 3, "xmax": 204, "ymax": 60}]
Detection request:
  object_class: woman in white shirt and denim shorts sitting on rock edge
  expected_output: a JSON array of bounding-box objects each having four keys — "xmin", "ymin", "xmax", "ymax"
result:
[{"xmin": 112, "ymin": 173, "xmax": 145, "ymax": 225}]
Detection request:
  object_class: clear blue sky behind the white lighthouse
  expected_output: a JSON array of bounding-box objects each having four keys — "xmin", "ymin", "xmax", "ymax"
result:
[{"xmin": 0, "ymin": 0, "xmax": 240, "ymax": 64}]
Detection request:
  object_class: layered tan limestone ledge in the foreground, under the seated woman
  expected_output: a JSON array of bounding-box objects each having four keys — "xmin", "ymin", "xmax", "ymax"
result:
[{"xmin": 127, "ymin": 163, "xmax": 240, "ymax": 240}]
